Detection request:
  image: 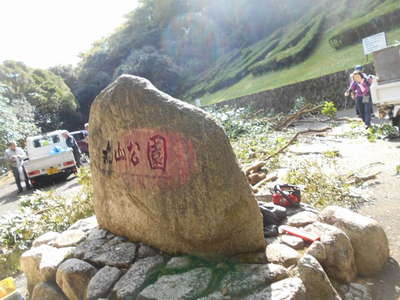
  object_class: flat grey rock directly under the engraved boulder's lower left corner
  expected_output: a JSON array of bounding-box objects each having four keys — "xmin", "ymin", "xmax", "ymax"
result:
[{"xmin": 88, "ymin": 243, "xmax": 137, "ymax": 268}]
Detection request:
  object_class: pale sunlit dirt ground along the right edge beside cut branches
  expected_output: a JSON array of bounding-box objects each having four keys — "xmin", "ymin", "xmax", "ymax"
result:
[{"xmin": 290, "ymin": 111, "xmax": 400, "ymax": 300}]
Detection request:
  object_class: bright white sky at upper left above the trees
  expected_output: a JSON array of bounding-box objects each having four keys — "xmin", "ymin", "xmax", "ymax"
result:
[{"xmin": 0, "ymin": 0, "xmax": 137, "ymax": 68}]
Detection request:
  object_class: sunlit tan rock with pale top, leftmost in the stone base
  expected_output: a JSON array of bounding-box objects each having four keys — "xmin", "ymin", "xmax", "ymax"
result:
[{"xmin": 20, "ymin": 245, "xmax": 53, "ymax": 293}]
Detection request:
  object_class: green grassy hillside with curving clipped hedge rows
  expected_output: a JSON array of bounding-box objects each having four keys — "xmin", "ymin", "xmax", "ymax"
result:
[{"xmin": 183, "ymin": 0, "xmax": 400, "ymax": 105}]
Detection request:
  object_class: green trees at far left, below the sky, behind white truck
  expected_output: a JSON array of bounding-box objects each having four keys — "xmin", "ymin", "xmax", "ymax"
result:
[{"xmin": 0, "ymin": 61, "xmax": 77, "ymax": 131}]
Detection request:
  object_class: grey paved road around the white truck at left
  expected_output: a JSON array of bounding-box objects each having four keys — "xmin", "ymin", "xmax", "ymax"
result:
[{"xmin": 0, "ymin": 176, "xmax": 80, "ymax": 216}]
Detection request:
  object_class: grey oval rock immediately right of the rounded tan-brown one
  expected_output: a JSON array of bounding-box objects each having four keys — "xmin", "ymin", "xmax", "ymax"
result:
[{"xmin": 87, "ymin": 266, "xmax": 122, "ymax": 300}]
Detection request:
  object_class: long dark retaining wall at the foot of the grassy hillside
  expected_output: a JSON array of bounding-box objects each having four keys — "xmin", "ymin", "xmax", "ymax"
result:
[{"xmin": 215, "ymin": 64, "xmax": 374, "ymax": 113}]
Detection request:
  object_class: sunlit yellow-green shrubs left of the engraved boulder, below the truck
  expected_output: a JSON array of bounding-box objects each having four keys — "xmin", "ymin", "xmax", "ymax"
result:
[{"xmin": 0, "ymin": 167, "xmax": 93, "ymax": 279}]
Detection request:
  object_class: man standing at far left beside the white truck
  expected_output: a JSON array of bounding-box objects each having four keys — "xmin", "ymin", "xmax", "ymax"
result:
[{"xmin": 4, "ymin": 142, "xmax": 31, "ymax": 193}]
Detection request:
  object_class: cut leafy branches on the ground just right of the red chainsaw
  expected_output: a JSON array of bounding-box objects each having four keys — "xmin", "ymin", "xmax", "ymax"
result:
[{"xmin": 287, "ymin": 161, "xmax": 360, "ymax": 208}]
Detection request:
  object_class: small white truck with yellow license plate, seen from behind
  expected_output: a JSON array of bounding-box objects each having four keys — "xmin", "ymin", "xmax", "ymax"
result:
[{"xmin": 23, "ymin": 130, "xmax": 77, "ymax": 186}]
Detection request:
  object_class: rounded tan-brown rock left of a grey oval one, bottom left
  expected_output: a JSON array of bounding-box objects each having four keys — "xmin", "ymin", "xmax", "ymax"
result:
[{"xmin": 56, "ymin": 258, "xmax": 97, "ymax": 300}]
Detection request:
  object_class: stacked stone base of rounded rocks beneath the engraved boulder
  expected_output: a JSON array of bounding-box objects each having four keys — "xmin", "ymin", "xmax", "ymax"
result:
[{"xmin": 21, "ymin": 207, "xmax": 389, "ymax": 300}]
